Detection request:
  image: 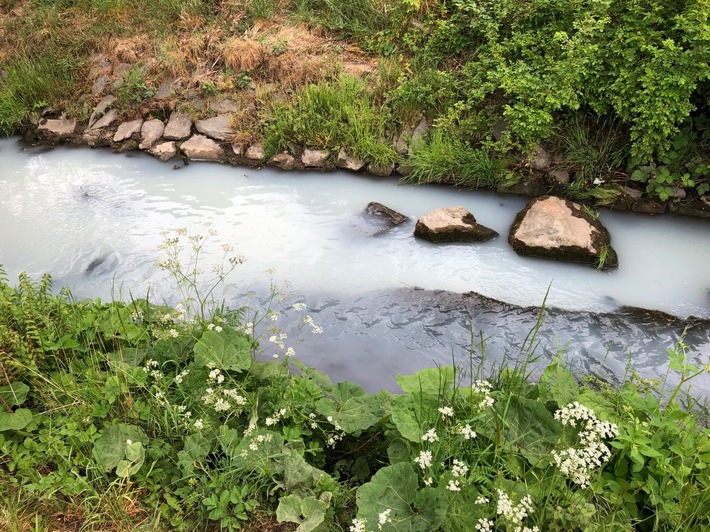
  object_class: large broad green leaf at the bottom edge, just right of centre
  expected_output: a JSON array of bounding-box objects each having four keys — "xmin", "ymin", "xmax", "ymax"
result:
[{"xmin": 357, "ymin": 462, "xmax": 448, "ymax": 532}]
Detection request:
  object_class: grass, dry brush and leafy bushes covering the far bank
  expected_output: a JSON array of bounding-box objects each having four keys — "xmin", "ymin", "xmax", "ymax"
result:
[{"xmin": 0, "ymin": 0, "xmax": 710, "ymax": 205}]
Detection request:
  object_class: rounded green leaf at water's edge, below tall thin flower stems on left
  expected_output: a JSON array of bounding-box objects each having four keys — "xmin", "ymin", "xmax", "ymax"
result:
[{"xmin": 195, "ymin": 327, "xmax": 252, "ymax": 371}]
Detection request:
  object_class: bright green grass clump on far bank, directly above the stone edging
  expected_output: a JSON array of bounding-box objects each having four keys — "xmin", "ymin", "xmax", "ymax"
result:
[{"xmin": 264, "ymin": 76, "xmax": 396, "ymax": 164}]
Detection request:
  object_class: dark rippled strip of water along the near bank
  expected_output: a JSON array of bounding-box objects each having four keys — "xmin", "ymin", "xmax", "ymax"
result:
[{"xmin": 268, "ymin": 288, "xmax": 710, "ymax": 396}]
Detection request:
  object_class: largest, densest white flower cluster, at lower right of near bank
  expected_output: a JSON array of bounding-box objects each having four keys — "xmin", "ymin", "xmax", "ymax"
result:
[{"xmin": 552, "ymin": 401, "xmax": 619, "ymax": 488}]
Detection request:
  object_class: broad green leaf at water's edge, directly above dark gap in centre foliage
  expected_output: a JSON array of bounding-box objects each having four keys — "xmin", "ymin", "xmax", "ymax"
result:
[{"xmin": 316, "ymin": 382, "xmax": 387, "ymax": 434}]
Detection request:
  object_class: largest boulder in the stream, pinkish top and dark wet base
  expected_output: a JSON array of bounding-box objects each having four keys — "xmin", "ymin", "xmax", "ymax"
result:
[{"xmin": 508, "ymin": 196, "xmax": 619, "ymax": 269}]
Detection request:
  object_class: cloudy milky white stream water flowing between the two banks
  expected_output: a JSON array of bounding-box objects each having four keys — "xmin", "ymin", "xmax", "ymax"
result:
[{"xmin": 0, "ymin": 139, "xmax": 710, "ymax": 388}]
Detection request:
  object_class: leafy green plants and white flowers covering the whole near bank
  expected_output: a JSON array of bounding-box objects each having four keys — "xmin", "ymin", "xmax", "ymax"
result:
[{"xmin": 0, "ymin": 231, "xmax": 710, "ymax": 531}]
